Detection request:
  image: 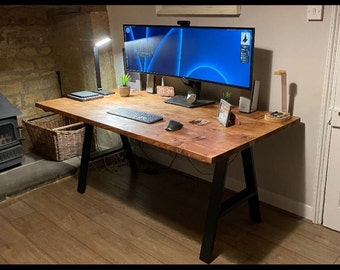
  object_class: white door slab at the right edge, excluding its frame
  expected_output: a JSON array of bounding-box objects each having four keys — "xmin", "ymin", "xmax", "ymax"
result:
[{"xmin": 323, "ymin": 77, "xmax": 340, "ymax": 231}]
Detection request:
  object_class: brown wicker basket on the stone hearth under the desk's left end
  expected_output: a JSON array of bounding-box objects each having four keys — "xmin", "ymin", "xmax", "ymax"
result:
[{"xmin": 22, "ymin": 114, "xmax": 85, "ymax": 161}]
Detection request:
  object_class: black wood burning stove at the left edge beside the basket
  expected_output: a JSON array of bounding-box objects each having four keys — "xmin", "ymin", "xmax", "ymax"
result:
[{"xmin": 0, "ymin": 93, "xmax": 23, "ymax": 171}]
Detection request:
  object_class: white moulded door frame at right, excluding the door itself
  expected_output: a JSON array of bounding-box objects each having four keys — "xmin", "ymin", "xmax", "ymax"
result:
[{"xmin": 312, "ymin": 5, "xmax": 340, "ymax": 224}]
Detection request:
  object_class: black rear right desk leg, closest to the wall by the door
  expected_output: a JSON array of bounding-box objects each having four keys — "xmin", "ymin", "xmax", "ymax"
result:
[{"xmin": 242, "ymin": 148, "xmax": 261, "ymax": 223}]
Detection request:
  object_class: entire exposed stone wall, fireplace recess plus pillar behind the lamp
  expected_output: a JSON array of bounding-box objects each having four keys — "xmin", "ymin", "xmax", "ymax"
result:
[{"xmin": 0, "ymin": 6, "xmax": 116, "ymax": 123}]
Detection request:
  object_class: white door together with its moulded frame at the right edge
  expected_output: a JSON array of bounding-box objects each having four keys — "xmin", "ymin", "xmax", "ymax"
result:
[{"xmin": 313, "ymin": 5, "xmax": 340, "ymax": 232}]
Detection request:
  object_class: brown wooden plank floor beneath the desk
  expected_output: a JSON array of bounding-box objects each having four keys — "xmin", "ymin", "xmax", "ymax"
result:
[{"xmin": 0, "ymin": 156, "xmax": 340, "ymax": 264}]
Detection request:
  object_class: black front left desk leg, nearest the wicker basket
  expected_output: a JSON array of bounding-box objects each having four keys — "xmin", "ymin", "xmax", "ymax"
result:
[{"xmin": 78, "ymin": 124, "xmax": 93, "ymax": 193}]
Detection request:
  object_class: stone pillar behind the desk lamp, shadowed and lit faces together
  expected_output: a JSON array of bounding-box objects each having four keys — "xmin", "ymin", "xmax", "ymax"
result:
[{"xmin": 52, "ymin": 11, "xmax": 115, "ymax": 95}]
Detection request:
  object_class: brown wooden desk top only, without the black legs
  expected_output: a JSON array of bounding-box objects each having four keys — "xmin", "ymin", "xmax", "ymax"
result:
[{"xmin": 36, "ymin": 91, "xmax": 299, "ymax": 164}]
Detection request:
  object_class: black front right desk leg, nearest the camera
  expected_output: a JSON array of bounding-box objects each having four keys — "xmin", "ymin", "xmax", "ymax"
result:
[{"xmin": 200, "ymin": 159, "xmax": 228, "ymax": 263}]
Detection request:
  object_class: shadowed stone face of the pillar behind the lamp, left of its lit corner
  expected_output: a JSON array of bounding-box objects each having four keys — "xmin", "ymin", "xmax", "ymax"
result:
[{"xmin": 52, "ymin": 13, "xmax": 95, "ymax": 95}]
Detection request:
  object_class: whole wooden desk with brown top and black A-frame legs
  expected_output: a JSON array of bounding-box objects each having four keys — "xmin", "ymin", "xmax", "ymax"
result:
[{"xmin": 36, "ymin": 91, "xmax": 300, "ymax": 263}]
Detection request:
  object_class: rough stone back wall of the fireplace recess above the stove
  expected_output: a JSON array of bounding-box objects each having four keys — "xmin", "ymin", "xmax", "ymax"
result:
[{"xmin": 0, "ymin": 7, "xmax": 60, "ymax": 122}]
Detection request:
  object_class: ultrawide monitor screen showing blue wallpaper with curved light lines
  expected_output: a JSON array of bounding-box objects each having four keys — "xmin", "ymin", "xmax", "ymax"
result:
[{"xmin": 123, "ymin": 24, "xmax": 255, "ymax": 90}]
